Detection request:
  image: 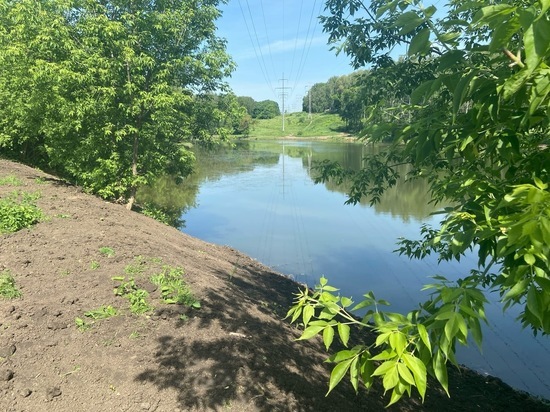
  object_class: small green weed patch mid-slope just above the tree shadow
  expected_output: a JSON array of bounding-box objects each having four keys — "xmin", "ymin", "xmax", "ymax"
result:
[{"xmin": 150, "ymin": 266, "xmax": 200, "ymax": 308}]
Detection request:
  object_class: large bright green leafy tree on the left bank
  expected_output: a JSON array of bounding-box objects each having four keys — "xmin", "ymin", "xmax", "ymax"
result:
[{"xmin": 0, "ymin": 0, "xmax": 233, "ymax": 208}]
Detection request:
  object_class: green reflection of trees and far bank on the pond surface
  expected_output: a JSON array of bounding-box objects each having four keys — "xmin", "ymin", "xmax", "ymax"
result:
[{"xmin": 138, "ymin": 141, "xmax": 446, "ymax": 227}]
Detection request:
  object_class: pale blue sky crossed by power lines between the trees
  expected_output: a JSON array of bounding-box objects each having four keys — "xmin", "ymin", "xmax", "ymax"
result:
[{"xmin": 217, "ymin": 0, "xmax": 353, "ymax": 113}]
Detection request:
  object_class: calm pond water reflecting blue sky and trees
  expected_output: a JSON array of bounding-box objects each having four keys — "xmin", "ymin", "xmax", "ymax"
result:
[{"xmin": 141, "ymin": 141, "xmax": 550, "ymax": 398}]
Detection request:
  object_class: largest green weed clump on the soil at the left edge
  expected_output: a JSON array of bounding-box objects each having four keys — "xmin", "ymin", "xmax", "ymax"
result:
[{"xmin": 0, "ymin": 191, "xmax": 44, "ymax": 233}]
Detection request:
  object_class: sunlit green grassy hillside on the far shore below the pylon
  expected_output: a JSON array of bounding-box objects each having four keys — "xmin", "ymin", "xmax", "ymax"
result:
[{"xmin": 249, "ymin": 112, "xmax": 345, "ymax": 139}]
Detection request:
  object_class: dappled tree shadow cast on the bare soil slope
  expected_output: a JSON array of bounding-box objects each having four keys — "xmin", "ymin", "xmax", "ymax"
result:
[{"xmin": 137, "ymin": 266, "xmax": 384, "ymax": 411}]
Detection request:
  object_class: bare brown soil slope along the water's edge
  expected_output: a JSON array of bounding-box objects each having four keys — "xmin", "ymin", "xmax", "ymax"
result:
[{"xmin": 0, "ymin": 160, "xmax": 550, "ymax": 412}]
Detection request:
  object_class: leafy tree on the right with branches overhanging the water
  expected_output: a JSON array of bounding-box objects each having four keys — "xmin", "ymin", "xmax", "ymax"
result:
[{"xmin": 288, "ymin": 0, "xmax": 550, "ymax": 404}]
